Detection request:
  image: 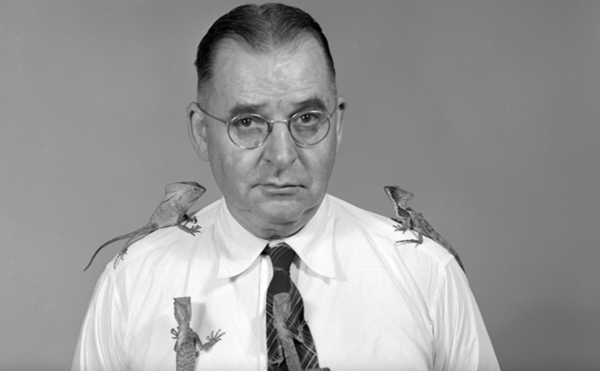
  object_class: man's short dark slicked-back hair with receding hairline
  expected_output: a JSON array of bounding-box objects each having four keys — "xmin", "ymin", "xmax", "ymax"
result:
[{"xmin": 194, "ymin": 3, "xmax": 335, "ymax": 101}]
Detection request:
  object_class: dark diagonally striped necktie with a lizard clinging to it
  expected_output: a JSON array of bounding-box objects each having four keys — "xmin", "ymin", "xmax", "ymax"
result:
[{"xmin": 264, "ymin": 243, "xmax": 326, "ymax": 371}]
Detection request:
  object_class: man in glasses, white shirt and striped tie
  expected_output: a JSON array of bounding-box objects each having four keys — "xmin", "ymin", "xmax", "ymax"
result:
[{"xmin": 73, "ymin": 4, "xmax": 499, "ymax": 371}]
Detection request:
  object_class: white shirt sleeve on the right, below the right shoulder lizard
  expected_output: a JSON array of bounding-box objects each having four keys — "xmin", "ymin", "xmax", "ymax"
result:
[{"xmin": 434, "ymin": 260, "xmax": 500, "ymax": 371}]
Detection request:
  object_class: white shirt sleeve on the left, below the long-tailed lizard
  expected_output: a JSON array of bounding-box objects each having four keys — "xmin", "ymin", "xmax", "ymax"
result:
[{"xmin": 71, "ymin": 269, "xmax": 127, "ymax": 371}]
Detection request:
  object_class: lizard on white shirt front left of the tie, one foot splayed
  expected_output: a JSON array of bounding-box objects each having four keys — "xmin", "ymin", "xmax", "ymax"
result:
[{"xmin": 171, "ymin": 296, "xmax": 225, "ymax": 371}]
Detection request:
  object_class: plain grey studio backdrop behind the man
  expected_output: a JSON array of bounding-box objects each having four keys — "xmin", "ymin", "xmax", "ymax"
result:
[{"xmin": 0, "ymin": 0, "xmax": 600, "ymax": 371}]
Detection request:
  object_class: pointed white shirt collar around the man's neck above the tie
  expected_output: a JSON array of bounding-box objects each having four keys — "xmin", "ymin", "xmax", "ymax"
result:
[{"xmin": 215, "ymin": 195, "xmax": 335, "ymax": 278}]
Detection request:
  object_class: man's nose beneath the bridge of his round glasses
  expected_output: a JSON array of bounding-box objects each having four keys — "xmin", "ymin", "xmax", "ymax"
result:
[{"xmin": 263, "ymin": 121, "xmax": 298, "ymax": 170}]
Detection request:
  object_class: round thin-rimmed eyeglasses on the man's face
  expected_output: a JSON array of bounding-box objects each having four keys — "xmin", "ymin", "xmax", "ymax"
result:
[{"xmin": 198, "ymin": 106, "xmax": 337, "ymax": 149}]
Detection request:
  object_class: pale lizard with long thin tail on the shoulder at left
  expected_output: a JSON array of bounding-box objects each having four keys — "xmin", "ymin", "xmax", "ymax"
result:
[{"xmin": 83, "ymin": 182, "xmax": 206, "ymax": 271}]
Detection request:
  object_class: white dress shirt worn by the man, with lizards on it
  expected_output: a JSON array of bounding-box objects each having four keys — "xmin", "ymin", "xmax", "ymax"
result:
[{"xmin": 72, "ymin": 195, "xmax": 499, "ymax": 371}]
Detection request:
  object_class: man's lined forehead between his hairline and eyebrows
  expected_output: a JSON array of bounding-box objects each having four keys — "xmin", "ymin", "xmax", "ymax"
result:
[{"xmin": 211, "ymin": 39, "xmax": 333, "ymax": 109}]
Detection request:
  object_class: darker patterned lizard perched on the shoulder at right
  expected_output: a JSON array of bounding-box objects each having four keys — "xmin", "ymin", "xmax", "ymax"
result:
[{"xmin": 383, "ymin": 186, "xmax": 465, "ymax": 271}]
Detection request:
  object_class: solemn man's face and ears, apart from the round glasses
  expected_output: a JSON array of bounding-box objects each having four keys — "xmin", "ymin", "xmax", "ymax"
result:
[{"xmin": 188, "ymin": 39, "xmax": 344, "ymax": 239}]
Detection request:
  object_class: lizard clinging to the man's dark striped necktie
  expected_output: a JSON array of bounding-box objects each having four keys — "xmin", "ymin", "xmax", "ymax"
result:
[{"xmin": 273, "ymin": 292, "xmax": 329, "ymax": 371}]
